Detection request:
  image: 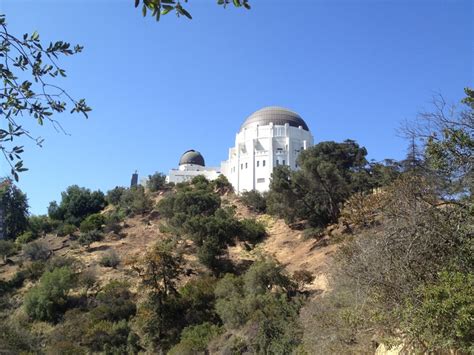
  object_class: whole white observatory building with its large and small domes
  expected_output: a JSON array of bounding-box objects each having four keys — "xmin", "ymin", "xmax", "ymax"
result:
[{"xmin": 167, "ymin": 107, "xmax": 313, "ymax": 193}]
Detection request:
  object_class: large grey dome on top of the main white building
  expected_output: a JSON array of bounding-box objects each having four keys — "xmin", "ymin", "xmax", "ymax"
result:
[{"xmin": 240, "ymin": 106, "xmax": 309, "ymax": 131}]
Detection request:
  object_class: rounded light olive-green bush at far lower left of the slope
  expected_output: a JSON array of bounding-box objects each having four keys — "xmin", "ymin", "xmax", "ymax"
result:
[{"xmin": 24, "ymin": 267, "xmax": 74, "ymax": 322}]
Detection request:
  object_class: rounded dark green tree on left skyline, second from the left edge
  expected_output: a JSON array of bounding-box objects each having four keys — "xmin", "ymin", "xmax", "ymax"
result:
[{"xmin": 48, "ymin": 185, "xmax": 106, "ymax": 226}]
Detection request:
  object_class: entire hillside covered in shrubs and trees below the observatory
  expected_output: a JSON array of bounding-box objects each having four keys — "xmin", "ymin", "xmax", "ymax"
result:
[{"xmin": 0, "ymin": 90, "xmax": 474, "ymax": 354}]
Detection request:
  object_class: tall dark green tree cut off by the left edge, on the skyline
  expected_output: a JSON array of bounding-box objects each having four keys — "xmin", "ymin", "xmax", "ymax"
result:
[{"xmin": 0, "ymin": 179, "xmax": 28, "ymax": 239}]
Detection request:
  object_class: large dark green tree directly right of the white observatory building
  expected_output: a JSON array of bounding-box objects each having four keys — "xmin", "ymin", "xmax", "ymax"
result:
[{"xmin": 268, "ymin": 140, "xmax": 371, "ymax": 226}]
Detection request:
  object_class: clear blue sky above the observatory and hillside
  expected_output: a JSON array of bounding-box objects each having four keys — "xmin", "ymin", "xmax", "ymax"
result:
[{"xmin": 0, "ymin": 0, "xmax": 474, "ymax": 214}]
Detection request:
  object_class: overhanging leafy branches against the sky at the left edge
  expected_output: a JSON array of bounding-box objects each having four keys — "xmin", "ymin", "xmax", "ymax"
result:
[{"xmin": 0, "ymin": 15, "xmax": 91, "ymax": 180}]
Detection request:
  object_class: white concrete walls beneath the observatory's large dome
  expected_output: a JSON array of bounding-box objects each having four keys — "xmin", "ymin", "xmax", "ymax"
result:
[{"xmin": 221, "ymin": 123, "xmax": 313, "ymax": 193}]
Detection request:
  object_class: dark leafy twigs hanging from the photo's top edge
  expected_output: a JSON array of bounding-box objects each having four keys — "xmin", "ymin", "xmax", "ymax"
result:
[{"xmin": 135, "ymin": 0, "xmax": 250, "ymax": 21}]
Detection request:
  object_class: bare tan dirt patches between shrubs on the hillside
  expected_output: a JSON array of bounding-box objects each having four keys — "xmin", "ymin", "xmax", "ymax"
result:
[{"xmin": 0, "ymin": 196, "xmax": 336, "ymax": 292}]
